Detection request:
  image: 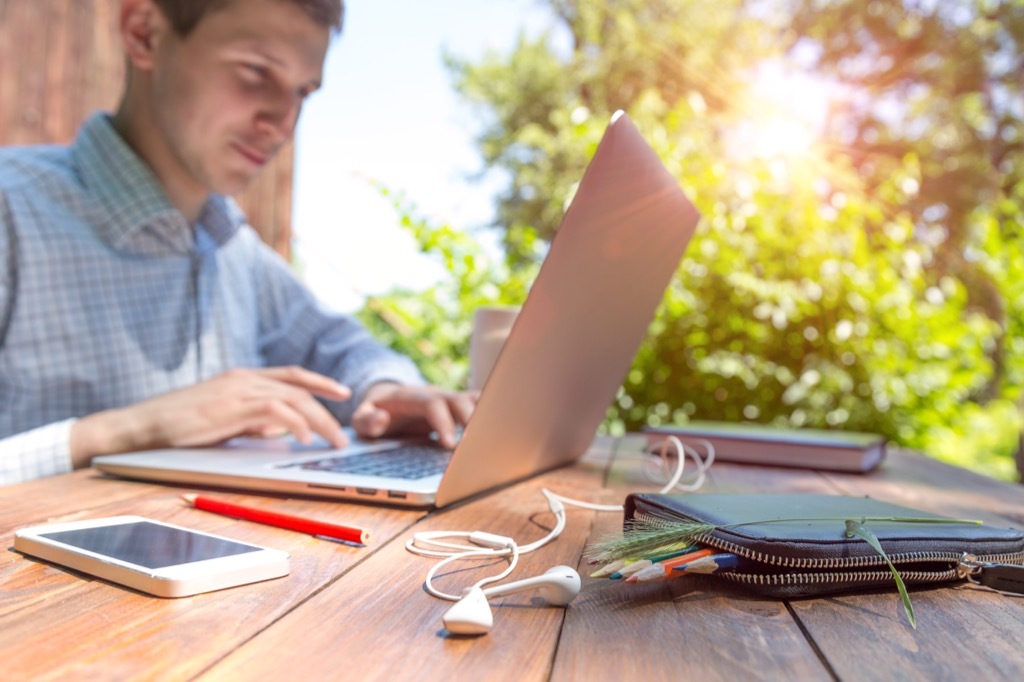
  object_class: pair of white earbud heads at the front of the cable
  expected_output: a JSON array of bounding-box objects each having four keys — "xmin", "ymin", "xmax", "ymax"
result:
[{"xmin": 442, "ymin": 566, "xmax": 580, "ymax": 635}]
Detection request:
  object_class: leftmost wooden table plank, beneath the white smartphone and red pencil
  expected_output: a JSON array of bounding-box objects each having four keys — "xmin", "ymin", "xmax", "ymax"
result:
[{"xmin": 0, "ymin": 475, "xmax": 424, "ymax": 679}]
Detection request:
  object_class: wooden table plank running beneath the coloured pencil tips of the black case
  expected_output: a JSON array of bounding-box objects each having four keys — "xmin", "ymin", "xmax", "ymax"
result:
[{"xmin": 552, "ymin": 441, "xmax": 831, "ymax": 681}]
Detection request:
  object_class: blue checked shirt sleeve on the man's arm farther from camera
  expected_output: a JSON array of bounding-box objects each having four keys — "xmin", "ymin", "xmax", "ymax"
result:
[{"xmin": 247, "ymin": 228, "xmax": 425, "ymax": 422}]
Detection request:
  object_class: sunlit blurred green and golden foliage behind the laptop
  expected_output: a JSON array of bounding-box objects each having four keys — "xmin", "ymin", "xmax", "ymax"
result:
[{"xmin": 362, "ymin": 0, "xmax": 1024, "ymax": 478}]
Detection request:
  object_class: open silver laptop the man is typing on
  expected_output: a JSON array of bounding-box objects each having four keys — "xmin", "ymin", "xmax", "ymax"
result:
[{"xmin": 93, "ymin": 112, "xmax": 699, "ymax": 507}]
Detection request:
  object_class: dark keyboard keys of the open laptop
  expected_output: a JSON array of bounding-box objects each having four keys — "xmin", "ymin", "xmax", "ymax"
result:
[{"xmin": 283, "ymin": 444, "xmax": 452, "ymax": 480}]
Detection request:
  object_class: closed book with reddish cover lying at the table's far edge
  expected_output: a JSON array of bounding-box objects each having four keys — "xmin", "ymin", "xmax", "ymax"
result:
[{"xmin": 644, "ymin": 422, "xmax": 886, "ymax": 473}]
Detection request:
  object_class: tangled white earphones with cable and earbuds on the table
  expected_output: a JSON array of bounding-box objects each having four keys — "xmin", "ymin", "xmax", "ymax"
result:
[{"xmin": 406, "ymin": 436, "xmax": 715, "ymax": 622}]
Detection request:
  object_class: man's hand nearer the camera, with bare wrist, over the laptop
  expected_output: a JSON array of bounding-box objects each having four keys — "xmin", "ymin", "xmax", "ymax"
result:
[{"xmin": 71, "ymin": 367, "xmax": 351, "ymax": 466}]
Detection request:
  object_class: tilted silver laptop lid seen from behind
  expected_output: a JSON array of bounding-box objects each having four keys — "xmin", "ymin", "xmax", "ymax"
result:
[{"xmin": 435, "ymin": 113, "xmax": 699, "ymax": 507}]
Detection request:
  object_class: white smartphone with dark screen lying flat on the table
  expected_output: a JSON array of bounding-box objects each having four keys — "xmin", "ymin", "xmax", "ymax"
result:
[{"xmin": 14, "ymin": 516, "xmax": 289, "ymax": 597}]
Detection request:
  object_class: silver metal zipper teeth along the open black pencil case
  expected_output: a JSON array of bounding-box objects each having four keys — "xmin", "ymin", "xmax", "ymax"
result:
[{"xmin": 635, "ymin": 513, "xmax": 1024, "ymax": 591}]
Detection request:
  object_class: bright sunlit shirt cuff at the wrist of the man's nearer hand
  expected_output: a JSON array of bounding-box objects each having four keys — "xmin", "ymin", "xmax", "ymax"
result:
[{"xmin": 0, "ymin": 419, "xmax": 77, "ymax": 485}]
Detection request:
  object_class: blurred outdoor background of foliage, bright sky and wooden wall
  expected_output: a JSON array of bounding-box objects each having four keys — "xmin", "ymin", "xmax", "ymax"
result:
[{"xmin": 0, "ymin": 0, "xmax": 1024, "ymax": 480}]
